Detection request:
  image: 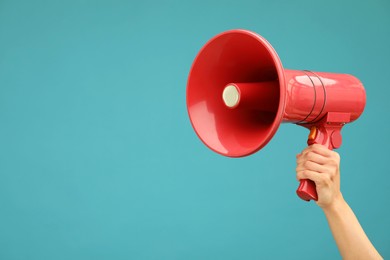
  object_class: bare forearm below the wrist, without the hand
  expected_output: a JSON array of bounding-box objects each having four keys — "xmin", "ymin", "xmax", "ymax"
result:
[{"xmin": 323, "ymin": 196, "xmax": 382, "ymax": 260}]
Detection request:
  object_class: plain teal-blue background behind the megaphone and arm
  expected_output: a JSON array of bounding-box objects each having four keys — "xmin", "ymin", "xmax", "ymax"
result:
[{"xmin": 0, "ymin": 0, "xmax": 390, "ymax": 260}]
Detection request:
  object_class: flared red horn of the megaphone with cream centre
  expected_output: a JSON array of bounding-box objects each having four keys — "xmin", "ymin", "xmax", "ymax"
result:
[{"xmin": 187, "ymin": 30, "xmax": 285, "ymax": 157}]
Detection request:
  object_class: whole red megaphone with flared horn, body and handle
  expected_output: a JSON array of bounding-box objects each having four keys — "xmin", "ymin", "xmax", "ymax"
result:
[{"xmin": 186, "ymin": 30, "xmax": 366, "ymax": 201}]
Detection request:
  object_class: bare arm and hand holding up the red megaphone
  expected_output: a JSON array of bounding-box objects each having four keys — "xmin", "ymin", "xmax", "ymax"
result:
[{"xmin": 296, "ymin": 144, "xmax": 382, "ymax": 259}]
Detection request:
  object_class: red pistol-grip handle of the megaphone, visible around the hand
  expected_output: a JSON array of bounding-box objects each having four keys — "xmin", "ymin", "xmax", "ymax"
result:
[{"xmin": 297, "ymin": 125, "xmax": 342, "ymax": 201}]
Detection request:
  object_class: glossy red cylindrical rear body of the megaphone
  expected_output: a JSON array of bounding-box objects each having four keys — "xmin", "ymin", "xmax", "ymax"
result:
[{"xmin": 283, "ymin": 70, "xmax": 366, "ymax": 123}]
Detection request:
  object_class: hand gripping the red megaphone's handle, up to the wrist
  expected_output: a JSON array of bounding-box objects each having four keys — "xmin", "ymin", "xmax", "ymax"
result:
[{"xmin": 296, "ymin": 144, "xmax": 342, "ymax": 209}]
